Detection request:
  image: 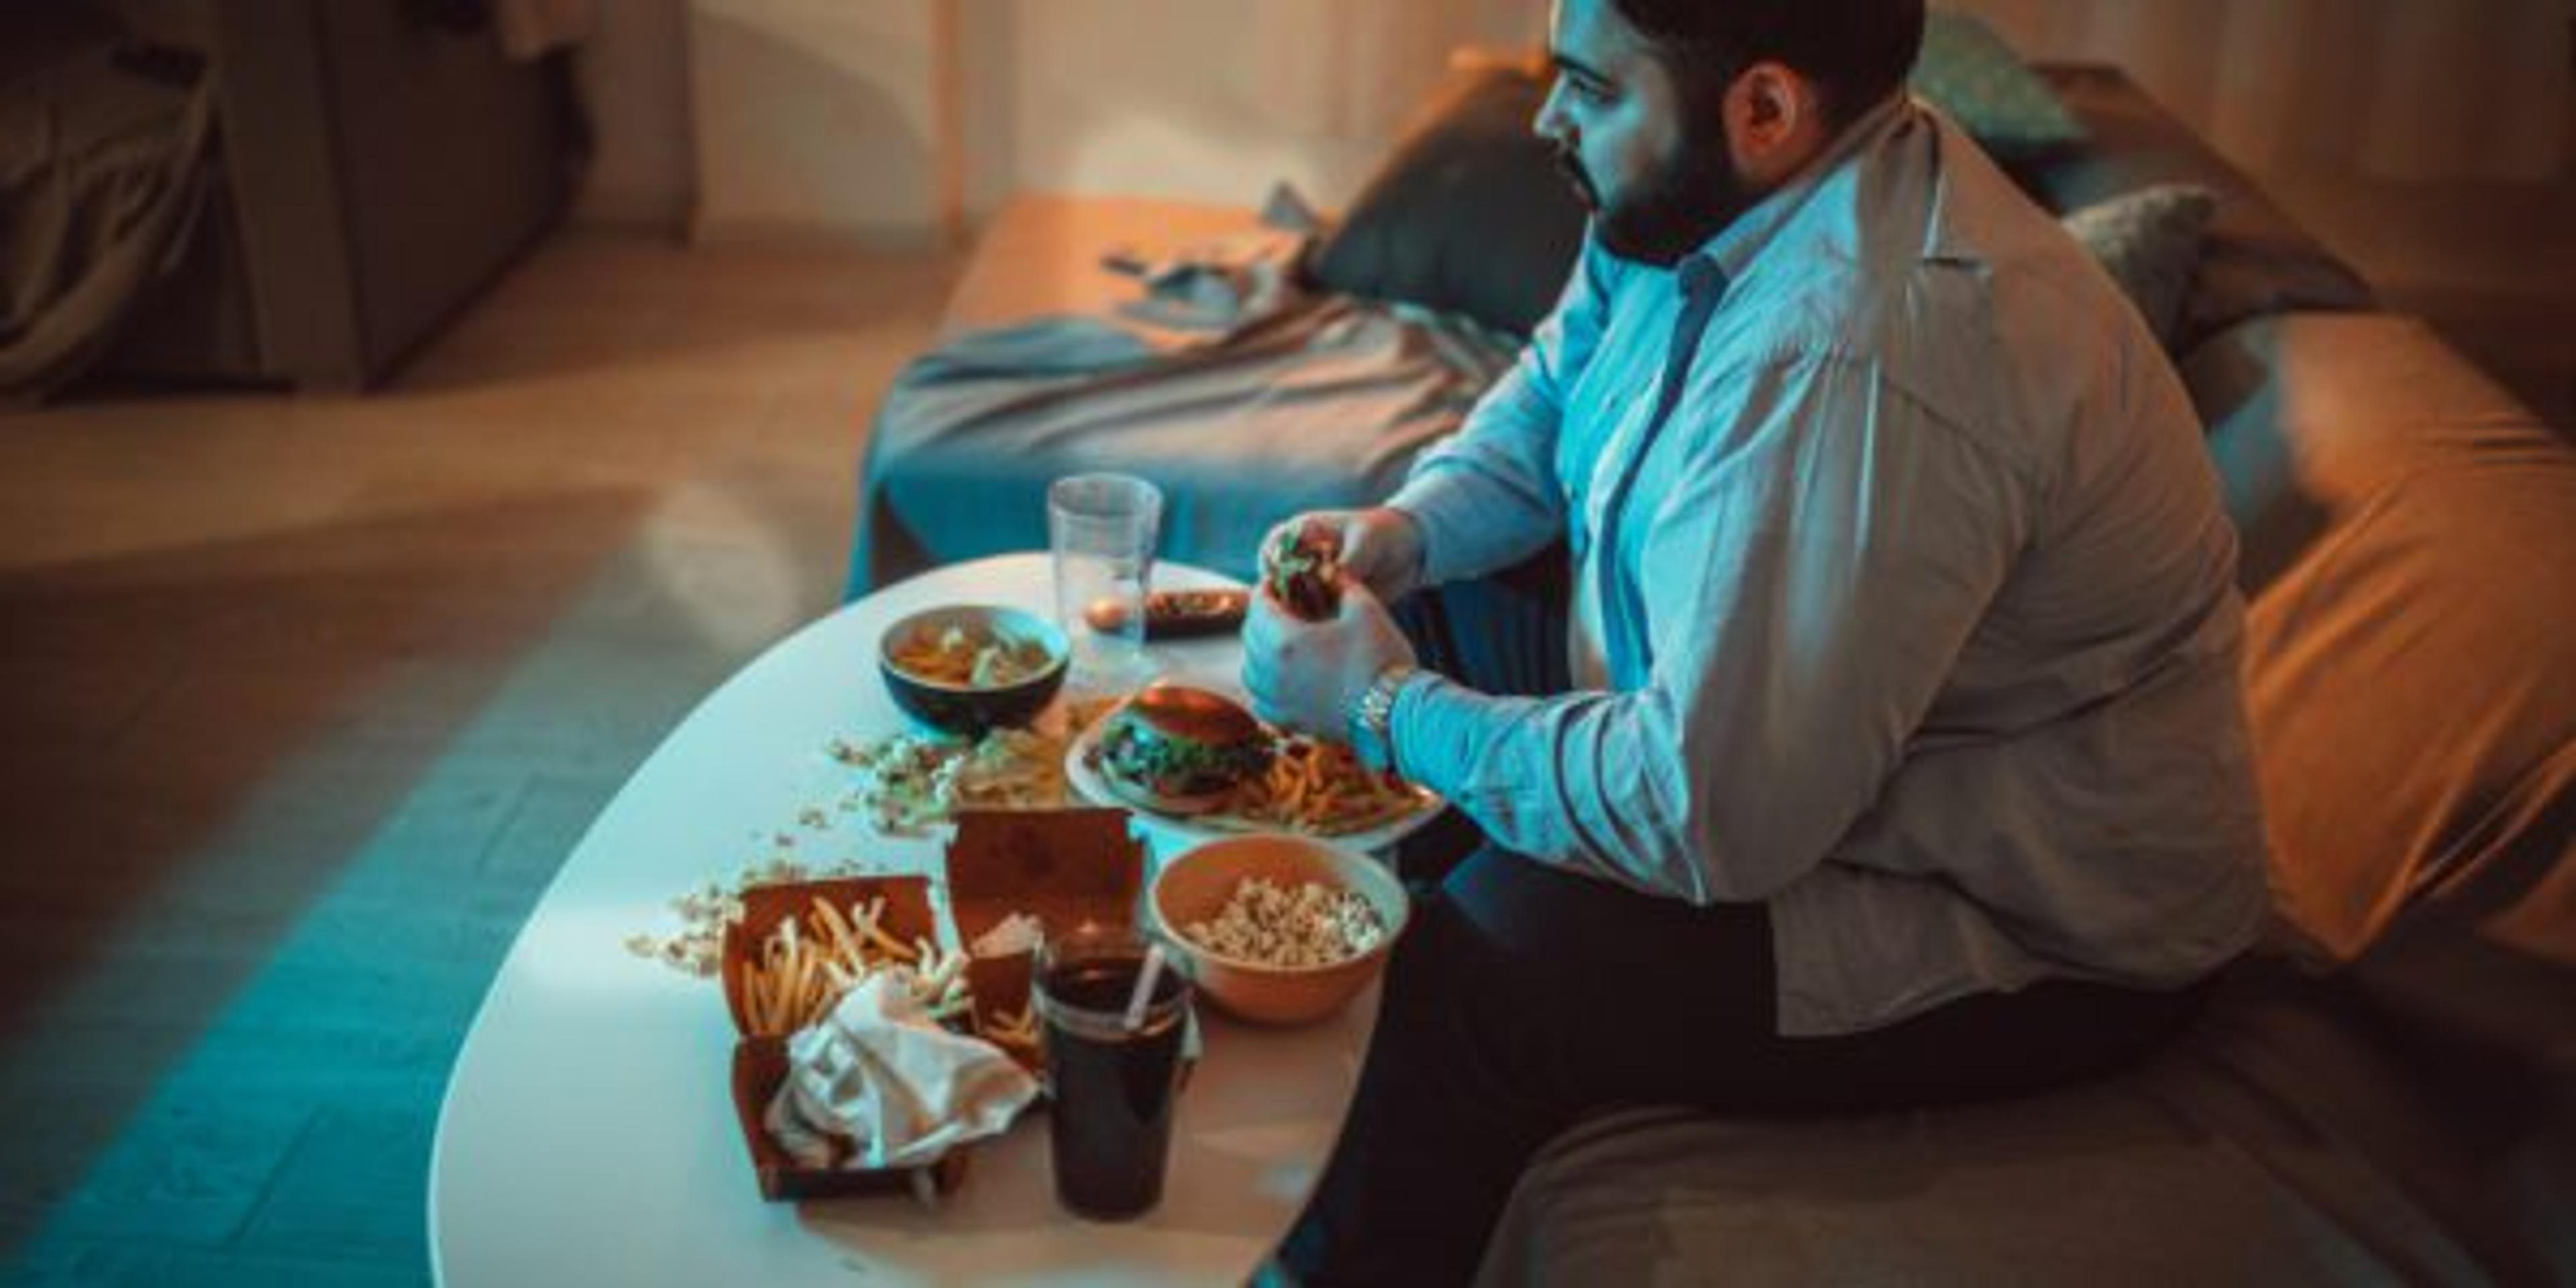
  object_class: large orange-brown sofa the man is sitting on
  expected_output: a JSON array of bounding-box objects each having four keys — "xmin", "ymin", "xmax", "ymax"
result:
[{"xmin": 853, "ymin": 55, "xmax": 2576, "ymax": 1283}]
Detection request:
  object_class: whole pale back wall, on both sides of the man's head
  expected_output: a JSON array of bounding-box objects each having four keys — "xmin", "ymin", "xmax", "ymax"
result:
[{"xmin": 582, "ymin": 0, "xmax": 2576, "ymax": 245}]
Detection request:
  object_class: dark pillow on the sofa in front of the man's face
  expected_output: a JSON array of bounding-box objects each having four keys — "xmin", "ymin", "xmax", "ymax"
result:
[{"xmin": 1311, "ymin": 70, "xmax": 1585, "ymax": 335}]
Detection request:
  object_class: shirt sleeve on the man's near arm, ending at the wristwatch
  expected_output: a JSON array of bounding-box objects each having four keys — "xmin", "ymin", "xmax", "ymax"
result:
[{"xmin": 1393, "ymin": 347, "xmax": 2033, "ymax": 904}]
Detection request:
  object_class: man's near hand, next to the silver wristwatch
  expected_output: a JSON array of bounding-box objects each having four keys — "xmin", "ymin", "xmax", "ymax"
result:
[{"xmin": 1244, "ymin": 577, "xmax": 1414, "ymax": 742}]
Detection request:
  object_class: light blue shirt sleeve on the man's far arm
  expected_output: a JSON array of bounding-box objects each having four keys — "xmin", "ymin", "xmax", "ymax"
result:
[{"xmin": 1389, "ymin": 234, "xmax": 1618, "ymax": 585}]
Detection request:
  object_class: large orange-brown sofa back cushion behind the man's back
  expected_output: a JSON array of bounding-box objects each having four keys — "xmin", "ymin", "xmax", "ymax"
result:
[{"xmin": 2184, "ymin": 314, "xmax": 2576, "ymax": 1071}]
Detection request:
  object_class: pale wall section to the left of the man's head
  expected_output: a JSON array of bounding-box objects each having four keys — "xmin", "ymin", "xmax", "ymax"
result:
[{"xmin": 580, "ymin": 0, "xmax": 1546, "ymax": 245}]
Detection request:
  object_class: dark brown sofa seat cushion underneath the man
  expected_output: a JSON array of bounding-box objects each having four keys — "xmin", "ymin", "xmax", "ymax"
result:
[{"xmin": 1479, "ymin": 963, "xmax": 2576, "ymax": 1285}]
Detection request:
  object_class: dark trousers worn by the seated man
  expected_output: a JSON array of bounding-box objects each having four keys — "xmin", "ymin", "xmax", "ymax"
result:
[{"xmin": 1280, "ymin": 553, "xmax": 2198, "ymax": 1285}]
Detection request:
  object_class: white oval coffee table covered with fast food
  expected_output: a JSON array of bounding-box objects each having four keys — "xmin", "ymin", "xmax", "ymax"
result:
[{"xmin": 430, "ymin": 554, "xmax": 1376, "ymax": 1288}]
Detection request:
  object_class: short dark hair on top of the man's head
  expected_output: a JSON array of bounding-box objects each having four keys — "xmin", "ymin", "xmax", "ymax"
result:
[{"xmin": 1610, "ymin": 0, "xmax": 1924, "ymax": 129}]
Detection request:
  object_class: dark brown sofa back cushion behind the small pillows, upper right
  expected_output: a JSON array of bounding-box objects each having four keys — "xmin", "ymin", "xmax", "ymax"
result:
[{"xmin": 2006, "ymin": 67, "xmax": 2373, "ymax": 353}]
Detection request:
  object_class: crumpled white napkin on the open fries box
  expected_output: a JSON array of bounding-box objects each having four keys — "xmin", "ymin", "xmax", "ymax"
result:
[{"xmin": 763, "ymin": 971, "xmax": 1038, "ymax": 1167}]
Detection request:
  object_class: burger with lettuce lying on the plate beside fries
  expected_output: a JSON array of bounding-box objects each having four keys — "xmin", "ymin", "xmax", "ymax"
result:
[{"xmin": 1097, "ymin": 683, "xmax": 1270, "ymax": 814}]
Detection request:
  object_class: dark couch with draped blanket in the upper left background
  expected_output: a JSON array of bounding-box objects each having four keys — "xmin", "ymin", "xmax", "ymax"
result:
[{"xmin": 0, "ymin": 0, "xmax": 580, "ymax": 399}]
